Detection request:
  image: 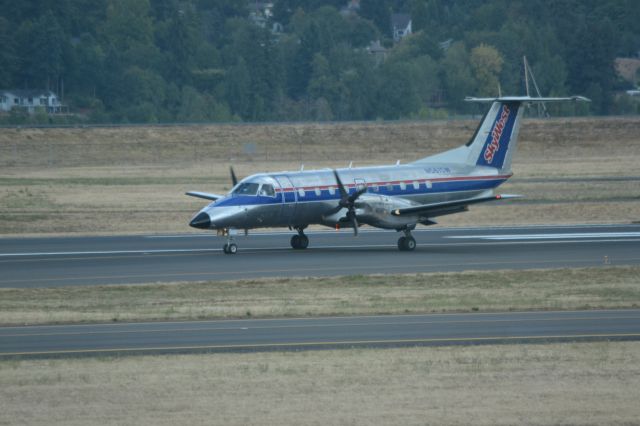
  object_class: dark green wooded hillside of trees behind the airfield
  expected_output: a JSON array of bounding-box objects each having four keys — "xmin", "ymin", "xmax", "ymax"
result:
[{"xmin": 0, "ymin": 0, "xmax": 640, "ymax": 123}]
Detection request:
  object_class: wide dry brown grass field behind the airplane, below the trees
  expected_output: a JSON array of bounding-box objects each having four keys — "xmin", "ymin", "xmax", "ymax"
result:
[{"xmin": 0, "ymin": 118, "xmax": 640, "ymax": 235}]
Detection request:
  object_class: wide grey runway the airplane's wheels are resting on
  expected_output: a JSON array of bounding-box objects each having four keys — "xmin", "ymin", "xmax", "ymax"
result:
[{"xmin": 0, "ymin": 225, "xmax": 640, "ymax": 288}]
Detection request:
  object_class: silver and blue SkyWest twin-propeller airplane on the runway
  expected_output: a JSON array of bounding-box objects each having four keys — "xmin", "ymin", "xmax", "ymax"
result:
[{"xmin": 186, "ymin": 96, "xmax": 588, "ymax": 254}]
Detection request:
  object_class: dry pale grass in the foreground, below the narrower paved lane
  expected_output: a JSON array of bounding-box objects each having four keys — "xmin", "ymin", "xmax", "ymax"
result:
[{"xmin": 0, "ymin": 342, "xmax": 640, "ymax": 426}]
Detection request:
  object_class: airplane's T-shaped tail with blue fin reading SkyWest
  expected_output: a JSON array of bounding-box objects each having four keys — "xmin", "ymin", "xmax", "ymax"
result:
[{"xmin": 416, "ymin": 96, "xmax": 588, "ymax": 173}]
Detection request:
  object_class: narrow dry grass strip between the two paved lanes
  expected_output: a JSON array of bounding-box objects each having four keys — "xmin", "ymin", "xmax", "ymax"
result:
[{"xmin": 0, "ymin": 267, "xmax": 640, "ymax": 325}]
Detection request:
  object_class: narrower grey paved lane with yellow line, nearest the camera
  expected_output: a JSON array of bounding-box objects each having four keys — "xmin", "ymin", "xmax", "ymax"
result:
[{"xmin": 0, "ymin": 310, "xmax": 640, "ymax": 359}]
